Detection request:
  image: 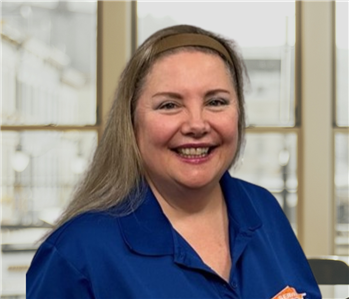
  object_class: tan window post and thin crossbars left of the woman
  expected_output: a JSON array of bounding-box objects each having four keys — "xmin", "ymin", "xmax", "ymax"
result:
[{"xmin": 0, "ymin": 0, "xmax": 131, "ymax": 229}]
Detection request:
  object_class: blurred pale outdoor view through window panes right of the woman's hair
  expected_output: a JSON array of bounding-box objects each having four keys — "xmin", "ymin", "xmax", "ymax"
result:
[{"xmin": 137, "ymin": 0, "xmax": 349, "ymax": 254}]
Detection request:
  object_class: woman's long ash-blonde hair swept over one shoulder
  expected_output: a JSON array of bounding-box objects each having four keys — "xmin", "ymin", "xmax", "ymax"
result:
[{"xmin": 51, "ymin": 25, "xmax": 246, "ymax": 228}]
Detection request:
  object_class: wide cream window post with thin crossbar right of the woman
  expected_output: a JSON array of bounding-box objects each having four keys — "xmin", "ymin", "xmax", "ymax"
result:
[{"xmin": 132, "ymin": 0, "xmax": 342, "ymax": 255}]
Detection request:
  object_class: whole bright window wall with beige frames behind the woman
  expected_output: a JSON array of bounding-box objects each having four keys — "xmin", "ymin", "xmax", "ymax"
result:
[{"xmin": 0, "ymin": 0, "xmax": 349, "ymax": 298}]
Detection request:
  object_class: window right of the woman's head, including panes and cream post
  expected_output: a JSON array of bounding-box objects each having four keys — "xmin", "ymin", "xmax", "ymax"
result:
[{"xmin": 137, "ymin": 0, "xmax": 349, "ymax": 255}]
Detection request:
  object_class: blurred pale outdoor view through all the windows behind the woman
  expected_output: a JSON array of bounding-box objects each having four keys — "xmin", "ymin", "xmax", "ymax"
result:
[{"xmin": 0, "ymin": 0, "xmax": 349, "ymax": 298}]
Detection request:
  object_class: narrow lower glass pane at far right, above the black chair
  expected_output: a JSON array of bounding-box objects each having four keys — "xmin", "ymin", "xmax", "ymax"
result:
[{"xmin": 335, "ymin": 133, "xmax": 349, "ymax": 255}]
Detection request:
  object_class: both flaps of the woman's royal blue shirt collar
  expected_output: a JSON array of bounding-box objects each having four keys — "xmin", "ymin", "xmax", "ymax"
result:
[{"xmin": 119, "ymin": 172, "xmax": 261, "ymax": 256}]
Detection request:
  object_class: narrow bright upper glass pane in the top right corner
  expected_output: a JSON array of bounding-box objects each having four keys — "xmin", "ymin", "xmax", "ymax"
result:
[{"xmin": 336, "ymin": 1, "xmax": 349, "ymax": 126}]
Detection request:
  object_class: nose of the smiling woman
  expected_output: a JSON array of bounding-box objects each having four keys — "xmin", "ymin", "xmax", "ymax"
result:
[{"xmin": 182, "ymin": 107, "xmax": 210, "ymax": 138}]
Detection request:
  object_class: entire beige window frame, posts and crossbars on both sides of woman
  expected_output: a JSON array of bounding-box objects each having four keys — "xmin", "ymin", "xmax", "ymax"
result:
[{"xmin": 0, "ymin": 0, "xmax": 348, "ymax": 255}]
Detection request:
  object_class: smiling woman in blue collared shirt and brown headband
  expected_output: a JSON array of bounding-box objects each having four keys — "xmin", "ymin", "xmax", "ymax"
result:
[{"xmin": 27, "ymin": 26, "xmax": 321, "ymax": 299}]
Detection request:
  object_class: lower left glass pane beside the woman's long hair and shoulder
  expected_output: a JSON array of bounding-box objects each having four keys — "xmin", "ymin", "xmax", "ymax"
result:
[{"xmin": 0, "ymin": 131, "xmax": 97, "ymax": 298}]
